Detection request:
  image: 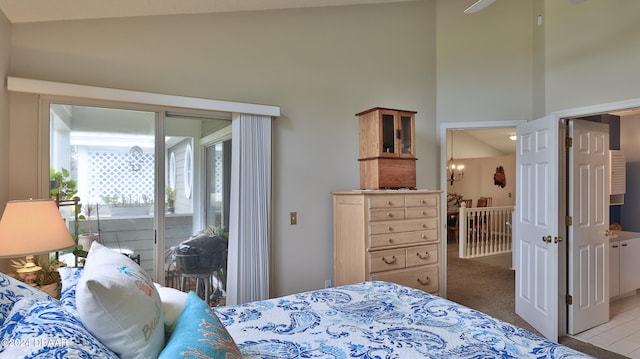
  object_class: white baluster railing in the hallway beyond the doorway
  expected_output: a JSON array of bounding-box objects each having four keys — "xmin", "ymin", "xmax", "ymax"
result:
[{"xmin": 458, "ymin": 206, "xmax": 513, "ymax": 258}]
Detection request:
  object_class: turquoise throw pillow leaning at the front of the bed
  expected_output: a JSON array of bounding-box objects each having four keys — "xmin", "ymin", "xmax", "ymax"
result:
[{"xmin": 159, "ymin": 292, "xmax": 242, "ymax": 359}]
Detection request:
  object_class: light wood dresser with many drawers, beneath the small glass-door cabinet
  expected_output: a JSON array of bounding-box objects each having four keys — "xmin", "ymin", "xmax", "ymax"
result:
[{"xmin": 333, "ymin": 190, "xmax": 442, "ymax": 294}]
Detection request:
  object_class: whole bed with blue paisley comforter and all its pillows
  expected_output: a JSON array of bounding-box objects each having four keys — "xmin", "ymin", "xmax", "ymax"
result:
[{"xmin": 0, "ymin": 243, "xmax": 589, "ymax": 359}]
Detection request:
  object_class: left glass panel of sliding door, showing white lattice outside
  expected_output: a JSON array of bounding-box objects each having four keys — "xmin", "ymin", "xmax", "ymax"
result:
[{"xmin": 50, "ymin": 104, "xmax": 156, "ymax": 274}]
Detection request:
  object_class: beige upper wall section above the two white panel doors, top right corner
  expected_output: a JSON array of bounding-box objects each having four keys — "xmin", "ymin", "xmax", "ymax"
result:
[{"xmin": 545, "ymin": 0, "xmax": 640, "ymax": 113}]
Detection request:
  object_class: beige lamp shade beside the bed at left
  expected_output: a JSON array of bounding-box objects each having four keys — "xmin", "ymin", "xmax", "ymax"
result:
[{"xmin": 0, "ymin": 199, "xmax": 75, "ymax": 258}]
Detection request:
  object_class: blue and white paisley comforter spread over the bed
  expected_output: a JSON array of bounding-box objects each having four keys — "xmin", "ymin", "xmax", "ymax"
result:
[{"xmin": 215, "ymin": 282, "xmax": 589, "ymax": 359}]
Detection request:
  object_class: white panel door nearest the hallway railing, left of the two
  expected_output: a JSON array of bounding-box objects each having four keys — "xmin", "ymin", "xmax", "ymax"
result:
[{"xmin": 513, "ymin": 116, "xmax": 559, "ymax": 341}]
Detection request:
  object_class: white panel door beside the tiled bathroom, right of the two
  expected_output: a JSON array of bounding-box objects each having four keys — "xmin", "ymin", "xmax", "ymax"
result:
[{"xmin": 567, "ymin": 120, "xmax": 609, "ymax": 334}]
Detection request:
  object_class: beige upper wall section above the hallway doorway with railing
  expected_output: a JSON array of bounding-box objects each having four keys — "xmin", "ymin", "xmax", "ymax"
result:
[{"xmin": 436, "ymin": 0, "xmax": 533, "ymax": 123}]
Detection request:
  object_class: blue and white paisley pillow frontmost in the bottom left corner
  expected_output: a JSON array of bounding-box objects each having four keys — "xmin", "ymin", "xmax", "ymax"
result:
[{"xmin": 0, "ymin": 298, "xmax": 117, "ymax": 359}]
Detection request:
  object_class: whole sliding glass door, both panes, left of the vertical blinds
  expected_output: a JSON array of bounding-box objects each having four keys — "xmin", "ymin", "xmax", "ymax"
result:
[{"xmin": 49, "ymin": 103, "xmax": 231, "ymax": 287}]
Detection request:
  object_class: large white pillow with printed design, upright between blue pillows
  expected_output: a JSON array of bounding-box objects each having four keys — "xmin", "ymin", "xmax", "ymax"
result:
[{"xmin": 76, "ymin": 242, "xmax": 164, "ymax": 359}]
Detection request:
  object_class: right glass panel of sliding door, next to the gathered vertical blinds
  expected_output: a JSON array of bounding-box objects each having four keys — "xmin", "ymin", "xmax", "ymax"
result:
[{"xmin": 164, "ymin": 114, "xmax": 231, "ymax": 304}]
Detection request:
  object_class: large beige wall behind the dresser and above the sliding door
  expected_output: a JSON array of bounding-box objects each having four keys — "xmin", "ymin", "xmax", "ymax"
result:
[{"xmin": 6, "ymin": 1, "xmax": 438, "ymax": 295}]
